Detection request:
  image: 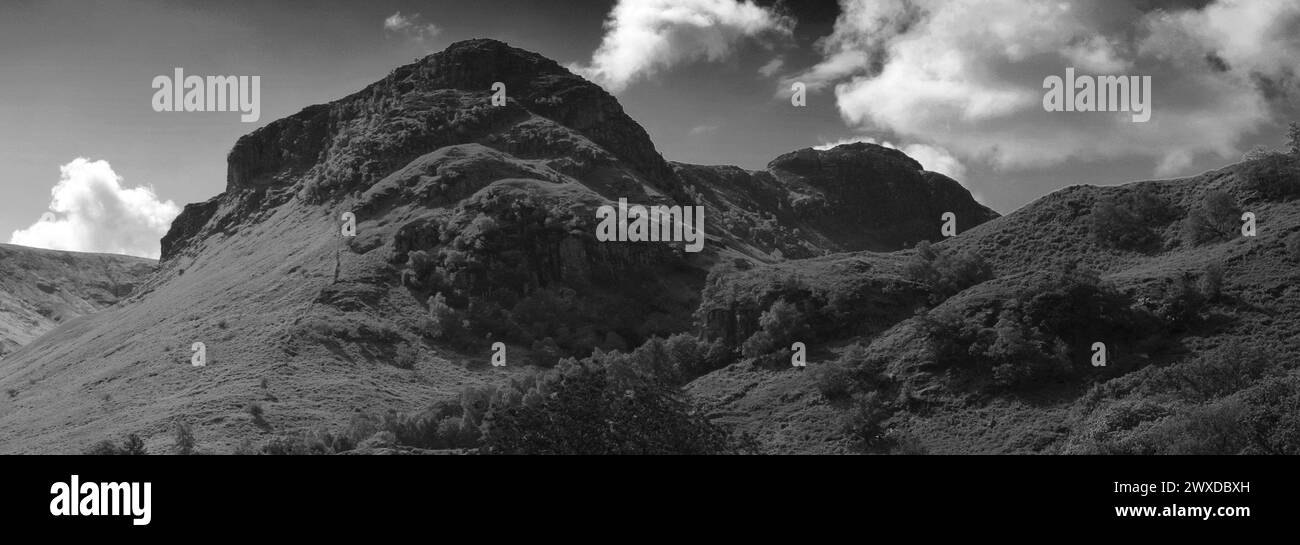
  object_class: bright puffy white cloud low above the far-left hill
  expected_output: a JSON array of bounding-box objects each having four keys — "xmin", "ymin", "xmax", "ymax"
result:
[{"xmin": 9, "ymin": 157, "xmax": 181, "ymax": 259}]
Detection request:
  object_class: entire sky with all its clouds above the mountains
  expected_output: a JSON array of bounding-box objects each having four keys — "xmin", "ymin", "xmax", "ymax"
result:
[{"xmin": 0, "ymin": 0, "xmax": 1300, "ymax": 258}]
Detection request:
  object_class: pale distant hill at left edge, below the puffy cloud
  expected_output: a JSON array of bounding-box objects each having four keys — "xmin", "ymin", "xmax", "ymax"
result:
[{"xmin": 0, "ymin": 245, "xmax": 156, "ymax": 358}]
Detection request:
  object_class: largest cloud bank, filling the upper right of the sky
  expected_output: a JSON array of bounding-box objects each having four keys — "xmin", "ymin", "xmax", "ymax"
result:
[{"xmin": 790, "ymin": 0, "xmax": 1300, "ymax": 176}]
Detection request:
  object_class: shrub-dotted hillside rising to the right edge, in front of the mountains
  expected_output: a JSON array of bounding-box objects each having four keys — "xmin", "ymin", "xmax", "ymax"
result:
[{"xmin": 688, "ymin": 160, "xmax": 1300, "ymax": 454}]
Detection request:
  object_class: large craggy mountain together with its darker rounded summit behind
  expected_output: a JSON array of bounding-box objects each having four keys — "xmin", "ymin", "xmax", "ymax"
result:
[{"xmin": 0, "ymin": 40, "xmax": 996, "ymax": 453}]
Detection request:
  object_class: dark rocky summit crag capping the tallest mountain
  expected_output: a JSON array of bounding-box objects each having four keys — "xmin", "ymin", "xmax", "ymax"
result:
[{"xmin": 226, "ymin": 39, "xmax": 672, "ymax": 196}]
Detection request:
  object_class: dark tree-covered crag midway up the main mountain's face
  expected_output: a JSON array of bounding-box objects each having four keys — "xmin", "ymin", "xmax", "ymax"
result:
[{"xmin": 398, "ymin": 189, "xmax": 702, "ymax": 366}]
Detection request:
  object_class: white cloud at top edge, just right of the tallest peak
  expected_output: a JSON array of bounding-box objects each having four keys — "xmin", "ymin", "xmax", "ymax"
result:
[{"xmin": 569, "ymin": 0, "xmax": 792, "ymax": 92}]
